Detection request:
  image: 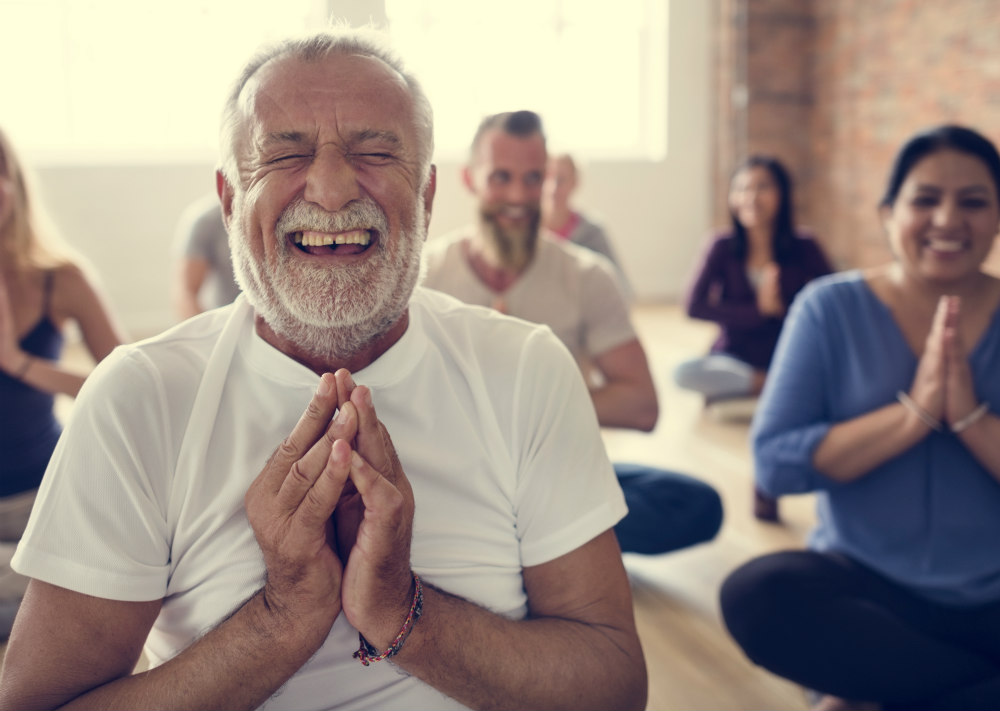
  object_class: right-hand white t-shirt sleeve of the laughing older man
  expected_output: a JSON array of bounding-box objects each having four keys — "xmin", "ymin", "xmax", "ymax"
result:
[{"xmin": 512, "ymin": 328, "xmax": 627, "ymax": 566}]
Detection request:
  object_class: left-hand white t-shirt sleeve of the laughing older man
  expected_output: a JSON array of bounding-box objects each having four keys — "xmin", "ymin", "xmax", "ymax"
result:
[{"xmin": 13, "ymin": 349, "xmax": 173, "ymax": 601}]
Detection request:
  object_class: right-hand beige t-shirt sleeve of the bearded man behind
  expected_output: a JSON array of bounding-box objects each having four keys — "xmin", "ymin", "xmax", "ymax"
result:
[{"xmin": 581, "ymin": 255, "xmax": 636, "ymax": 358}]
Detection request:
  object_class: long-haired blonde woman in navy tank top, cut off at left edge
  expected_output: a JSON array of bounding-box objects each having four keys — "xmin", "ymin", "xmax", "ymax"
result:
[{"xmin": 0, "ymin": 125, "xmax": 122, "ymax": 639}]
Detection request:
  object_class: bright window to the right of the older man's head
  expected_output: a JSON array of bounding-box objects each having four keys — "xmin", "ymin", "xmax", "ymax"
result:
[{"xmin": 386, "ymin": 0, "xmax": 667, "ymax": 159}]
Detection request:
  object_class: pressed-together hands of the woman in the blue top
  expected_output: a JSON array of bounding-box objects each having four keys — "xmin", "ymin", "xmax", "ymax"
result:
[{"xmin": 910, "ymin": 296, "xmax": 979, "ymax": 434}]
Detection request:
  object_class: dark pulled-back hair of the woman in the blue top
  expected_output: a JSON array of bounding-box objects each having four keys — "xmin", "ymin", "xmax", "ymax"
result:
[{"xmin": 879, "ymin": 124, "xmax": 1000, "ymax": 207}]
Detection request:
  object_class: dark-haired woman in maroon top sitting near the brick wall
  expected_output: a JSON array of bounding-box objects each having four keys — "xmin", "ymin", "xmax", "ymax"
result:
[{"xmin": 674, "ymin": 156, "xmax": 830, "ymax": 520}]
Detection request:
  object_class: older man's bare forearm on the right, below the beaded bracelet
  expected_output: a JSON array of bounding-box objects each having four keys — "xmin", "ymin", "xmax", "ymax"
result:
[{"xmin": 393, "ymin": 586, "xmax": 646, "ymax": 709}]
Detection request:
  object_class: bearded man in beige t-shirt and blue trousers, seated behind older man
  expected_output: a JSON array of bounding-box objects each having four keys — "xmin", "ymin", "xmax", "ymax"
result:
[{"xmin": 424, "ymin": 111, "xmax": 723, "ymax": 555}]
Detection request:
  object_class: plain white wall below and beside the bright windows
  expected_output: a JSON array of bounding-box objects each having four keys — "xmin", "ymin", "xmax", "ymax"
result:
[{"xmin": 37, "ymin": 0, "xmax": 712, "ymax": 336}]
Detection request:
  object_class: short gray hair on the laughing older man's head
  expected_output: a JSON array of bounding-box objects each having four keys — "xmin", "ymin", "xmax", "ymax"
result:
[{"xmin": 219, "ymin": 27, "xmax": 434, "ymax": 185}]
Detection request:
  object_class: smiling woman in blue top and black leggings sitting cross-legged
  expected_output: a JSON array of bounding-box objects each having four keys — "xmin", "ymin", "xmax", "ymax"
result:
[{"xmin": 721, "ymin": 126, "xmax": 1000, "ymax": 709}]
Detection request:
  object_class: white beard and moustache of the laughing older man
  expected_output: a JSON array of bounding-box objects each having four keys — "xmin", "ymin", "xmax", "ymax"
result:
[{"xmin": 229, "ymin": 196, "xmax": 426, "ymax": 360}]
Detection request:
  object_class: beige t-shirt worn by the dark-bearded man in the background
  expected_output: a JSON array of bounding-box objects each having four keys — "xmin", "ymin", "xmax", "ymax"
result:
[{"xmin": 423, "ymin": 234, "xmax": 636, "ymax": 364}]
